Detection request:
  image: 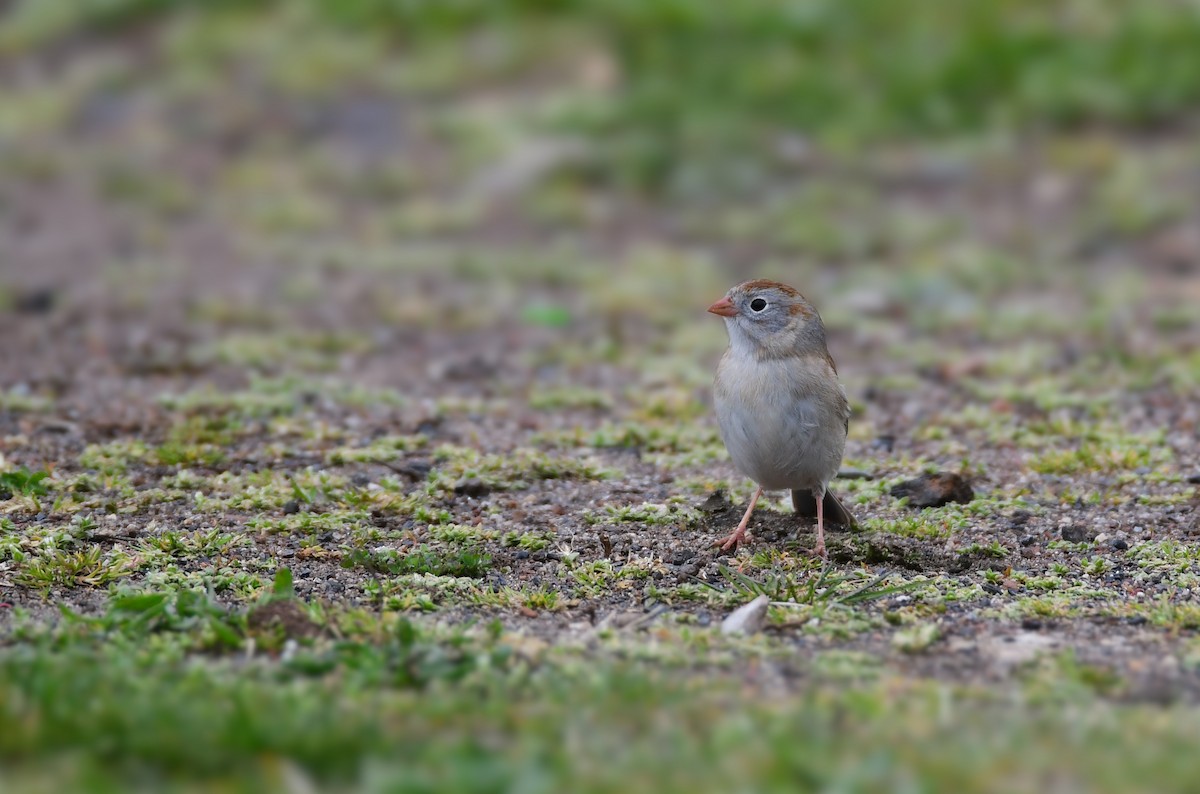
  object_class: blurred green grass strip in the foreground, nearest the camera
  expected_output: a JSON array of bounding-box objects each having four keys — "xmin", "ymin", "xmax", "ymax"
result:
[{"xmin": 7, "ymin": 606, "xmax": 1200, "ymax": 794}]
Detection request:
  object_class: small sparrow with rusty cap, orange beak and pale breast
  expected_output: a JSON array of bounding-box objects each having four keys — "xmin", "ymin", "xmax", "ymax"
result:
[{"xmin": 708, "ymin": 278, "xmax": 857, "ymax": 558}]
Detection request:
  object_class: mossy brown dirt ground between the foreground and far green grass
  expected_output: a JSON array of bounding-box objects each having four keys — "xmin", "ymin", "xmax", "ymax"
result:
[{"xmin": 0, "ymin": 15, "xmax": 1200, "ymax": 700}]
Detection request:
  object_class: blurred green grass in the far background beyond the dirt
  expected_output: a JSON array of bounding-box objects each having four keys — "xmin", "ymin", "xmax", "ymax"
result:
[{"xmin": 18, "ymin": 0, "xmax": 1200, "ymax": 193}]
